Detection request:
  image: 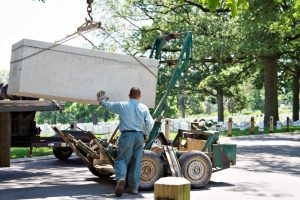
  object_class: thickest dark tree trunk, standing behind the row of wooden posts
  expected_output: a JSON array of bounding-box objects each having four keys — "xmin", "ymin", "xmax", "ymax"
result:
[{"xmin": 264, "ymin": 57, "xmax": 279, "ymax": 126}]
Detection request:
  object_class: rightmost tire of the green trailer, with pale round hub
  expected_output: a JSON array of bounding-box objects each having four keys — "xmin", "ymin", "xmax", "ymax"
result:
[{"xmin": 178, "ymin": 151, "xmax": 212, "ymax": 188}]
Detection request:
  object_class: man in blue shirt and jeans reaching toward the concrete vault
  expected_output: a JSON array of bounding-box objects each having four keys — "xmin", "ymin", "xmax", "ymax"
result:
[{"xmin": 97, "ymin": 87, "xmax": 153, "ymax": 196}]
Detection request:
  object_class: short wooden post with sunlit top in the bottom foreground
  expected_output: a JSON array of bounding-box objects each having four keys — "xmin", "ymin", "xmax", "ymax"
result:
[{"xmin": 154, "ymin": 177, "xmax": 191, "ymax": 200}]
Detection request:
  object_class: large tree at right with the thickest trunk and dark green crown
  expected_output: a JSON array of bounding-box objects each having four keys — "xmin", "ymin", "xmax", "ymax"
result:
[{"xmin": 240, "ymin": 0, "xmax": 300, "ymax": 124}]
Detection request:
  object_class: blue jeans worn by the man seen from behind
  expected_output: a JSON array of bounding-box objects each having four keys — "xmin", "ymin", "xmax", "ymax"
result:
[{"xmin": 114, "ymin": 132, "xmax": 144, "ymax": 189}]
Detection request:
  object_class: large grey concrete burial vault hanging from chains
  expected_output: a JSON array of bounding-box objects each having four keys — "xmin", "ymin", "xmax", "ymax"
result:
[{"xmin": 8, "ymin": 39, "xmax": 159, "ymax": 108}]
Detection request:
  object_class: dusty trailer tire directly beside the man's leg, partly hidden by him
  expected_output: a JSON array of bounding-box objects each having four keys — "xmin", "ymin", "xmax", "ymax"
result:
[{"xmin": 139, "ymin": 150, "xmax": 164, "ymax": 190}]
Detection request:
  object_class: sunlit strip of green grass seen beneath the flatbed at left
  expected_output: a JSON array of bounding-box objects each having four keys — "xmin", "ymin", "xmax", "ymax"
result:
[{"xmin": 10, "ymin": 147, "xmax": 52, "ymax": 159}]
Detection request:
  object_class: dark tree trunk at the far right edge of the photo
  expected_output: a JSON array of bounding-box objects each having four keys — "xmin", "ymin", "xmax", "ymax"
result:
[{"xmin": 293, "ymin": 69, "xmax": 300, "ymax": 121}]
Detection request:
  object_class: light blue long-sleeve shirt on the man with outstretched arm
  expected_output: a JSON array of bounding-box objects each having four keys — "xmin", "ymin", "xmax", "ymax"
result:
[{"xmin": 99, "ymin": 99, "xmax": 153, "ymax": 135}]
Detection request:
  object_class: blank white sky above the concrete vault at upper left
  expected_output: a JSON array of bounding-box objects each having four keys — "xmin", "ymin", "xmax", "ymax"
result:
[{"xmin": 0, "ymin": 0, "xmax": 87, "ymax": 70}]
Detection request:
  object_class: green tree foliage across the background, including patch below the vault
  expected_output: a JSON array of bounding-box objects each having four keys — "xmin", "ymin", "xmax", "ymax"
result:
[{"xmin": 31, "ymin": 0, "xmax": 300, "ymax": 121}]
